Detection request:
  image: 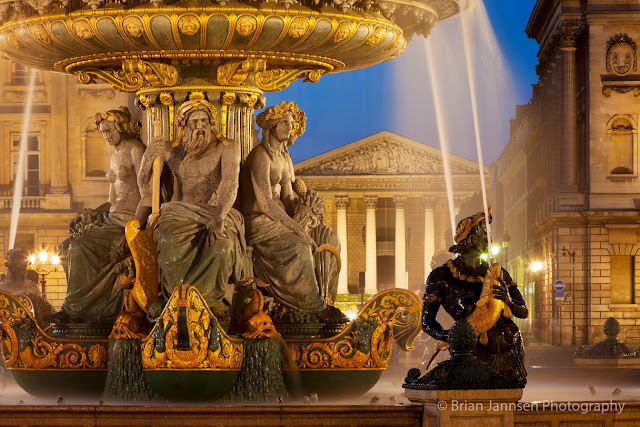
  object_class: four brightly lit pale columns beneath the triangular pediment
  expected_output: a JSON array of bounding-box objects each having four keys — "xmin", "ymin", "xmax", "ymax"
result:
[{"xmin": 335, "ymin": 196, "xmax": 435, "ymax": 294}]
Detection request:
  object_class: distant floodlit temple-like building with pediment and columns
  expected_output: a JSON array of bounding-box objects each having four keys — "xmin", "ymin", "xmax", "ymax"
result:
[{"xmin": 294, "ymin": 131, "xmax": 489, "ymax": 294}]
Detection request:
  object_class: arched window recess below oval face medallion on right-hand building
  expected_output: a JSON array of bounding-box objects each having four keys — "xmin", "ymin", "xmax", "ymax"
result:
[{"xmin": 607, "ymin": 115, "xmax": 637, "ymax": 176}]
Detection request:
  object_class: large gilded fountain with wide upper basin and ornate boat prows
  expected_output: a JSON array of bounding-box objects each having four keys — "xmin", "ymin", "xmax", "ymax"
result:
[{"xmin": 0, "ymin": 0, "xmax": 476, "ymax": 406}]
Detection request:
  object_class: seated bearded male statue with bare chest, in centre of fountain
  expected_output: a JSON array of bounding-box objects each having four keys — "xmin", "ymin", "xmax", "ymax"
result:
[{"xmin": 138, "ymin": 94, "xmax": 246, "ymax": 320}]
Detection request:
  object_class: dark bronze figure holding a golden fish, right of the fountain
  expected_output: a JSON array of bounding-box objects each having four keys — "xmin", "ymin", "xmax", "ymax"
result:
[{"xmin": 422, "ymin": 212, "xmax": 529, "ymax": 387}]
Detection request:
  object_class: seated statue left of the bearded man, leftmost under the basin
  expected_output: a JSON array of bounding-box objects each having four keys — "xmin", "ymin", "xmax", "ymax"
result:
[{"xmin": 46, "ymin": 107, "xmax": 145, "ymax": 323}]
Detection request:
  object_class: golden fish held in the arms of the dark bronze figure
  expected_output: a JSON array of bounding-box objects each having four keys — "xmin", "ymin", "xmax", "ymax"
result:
[{"xmin": 424, "ymin": 263, "xmax": 513, "ymax": 370}]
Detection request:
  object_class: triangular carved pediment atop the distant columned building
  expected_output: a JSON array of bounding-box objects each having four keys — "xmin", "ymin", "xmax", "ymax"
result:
[{"xmin": 294, "ymin": 131, "xmax": 488, "ymax": 176}]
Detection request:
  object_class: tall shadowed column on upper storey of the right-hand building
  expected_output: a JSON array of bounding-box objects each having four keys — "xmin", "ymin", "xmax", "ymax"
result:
[{"xmin": 560, "ymin": 27, "xmax": 579, "ymax": 190}]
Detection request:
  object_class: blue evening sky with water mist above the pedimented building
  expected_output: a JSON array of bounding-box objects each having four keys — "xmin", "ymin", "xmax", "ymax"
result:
[{"xmin": 265, "ymin": 0, "xmax": 538, "ymax": 165}]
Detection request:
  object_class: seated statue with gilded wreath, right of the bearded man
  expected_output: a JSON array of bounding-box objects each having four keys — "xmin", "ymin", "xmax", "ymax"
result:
[{"xmin": 241, "ymin": 101, "xmax": 347, "ymax": 323}]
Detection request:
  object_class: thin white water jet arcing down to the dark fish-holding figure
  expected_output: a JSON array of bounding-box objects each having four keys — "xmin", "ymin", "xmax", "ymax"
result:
[{"xmin": 460, "ymin": 0, "xmax": 494, "ymax": 262}]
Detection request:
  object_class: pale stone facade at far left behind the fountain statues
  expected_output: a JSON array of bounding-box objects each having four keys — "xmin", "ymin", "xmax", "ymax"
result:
[{"xmin": 0, "ymin": 60, "xmax": 135, "ymax": 307}]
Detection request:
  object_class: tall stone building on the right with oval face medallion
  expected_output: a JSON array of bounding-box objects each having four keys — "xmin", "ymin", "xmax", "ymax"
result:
[{"xmin": 491, "ymin": 0, "xmax": 640, "ymax": 345}]
